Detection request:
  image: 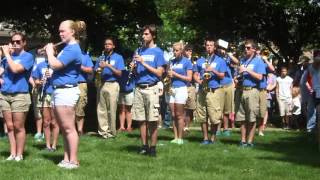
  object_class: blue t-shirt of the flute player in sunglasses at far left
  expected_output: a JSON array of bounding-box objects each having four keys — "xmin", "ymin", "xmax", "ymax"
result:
[{"xmin": 1, "ymin": 52, "xmax": 34, "ymax": 93}]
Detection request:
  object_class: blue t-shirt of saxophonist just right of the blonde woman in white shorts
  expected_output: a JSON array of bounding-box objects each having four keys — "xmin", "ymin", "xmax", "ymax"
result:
[{"xmin": 196, "ymin": 55, "xmax": 227, "ymax": 89}]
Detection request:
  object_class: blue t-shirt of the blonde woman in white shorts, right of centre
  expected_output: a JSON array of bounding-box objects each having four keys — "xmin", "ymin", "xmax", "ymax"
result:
[{"xmin": 170, "ymin": 57, "xmax": 192, "ymax": 88}]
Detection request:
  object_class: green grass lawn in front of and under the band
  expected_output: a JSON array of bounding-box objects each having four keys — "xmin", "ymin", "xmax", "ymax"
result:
[{"xmin": 0, "ymin": 130, "xmax": 320, "ymax": 180}]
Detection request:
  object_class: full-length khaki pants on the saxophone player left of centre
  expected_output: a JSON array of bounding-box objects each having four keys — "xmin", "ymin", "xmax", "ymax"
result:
[{"xmin": 97, "ymin": 82, "xmax": 120, "ymax": 136}]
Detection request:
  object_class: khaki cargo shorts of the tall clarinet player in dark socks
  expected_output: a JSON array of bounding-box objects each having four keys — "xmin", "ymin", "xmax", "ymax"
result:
[{"xmin": 132, "ymin": 86, "xmax": 160, "ymax": 121}]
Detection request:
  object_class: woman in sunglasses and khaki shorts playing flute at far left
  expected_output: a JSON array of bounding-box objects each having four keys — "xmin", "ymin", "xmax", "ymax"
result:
[{"xmin": 0, "ymin": 33, "xmax": 34, "ymax": 161}]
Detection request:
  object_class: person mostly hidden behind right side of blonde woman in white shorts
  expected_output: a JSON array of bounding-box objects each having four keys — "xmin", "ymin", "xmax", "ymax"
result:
[{"xmin": 184, "ymin": 44, "xmax": 196, "ymax": 132}]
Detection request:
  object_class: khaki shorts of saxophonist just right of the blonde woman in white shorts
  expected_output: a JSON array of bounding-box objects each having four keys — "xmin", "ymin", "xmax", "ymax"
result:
[{"xmin": 196, "ymin": 88, "xmax": 223, "ymax": 124}]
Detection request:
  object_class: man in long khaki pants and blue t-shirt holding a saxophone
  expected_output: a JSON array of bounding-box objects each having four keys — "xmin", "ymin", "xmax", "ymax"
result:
[{"xmin": 95, "ymin": 37, "xmax": 124, "ymax": 139}]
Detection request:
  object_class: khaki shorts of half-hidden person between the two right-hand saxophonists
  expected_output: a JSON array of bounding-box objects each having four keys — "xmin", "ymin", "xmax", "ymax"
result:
[{"xmin": 220, "ymin": 84, "xmax": 234, "ymax": 114}]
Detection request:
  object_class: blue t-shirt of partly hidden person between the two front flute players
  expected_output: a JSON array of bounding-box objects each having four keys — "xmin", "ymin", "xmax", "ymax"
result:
[{"xmin": 32, "ymin": 61, "xmax": 53, "ymax": 94}]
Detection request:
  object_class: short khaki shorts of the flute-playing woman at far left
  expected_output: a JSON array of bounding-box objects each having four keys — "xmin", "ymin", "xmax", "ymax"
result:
[{"xmin": 0, "ymin": 93, "xmax": 31, "ymax": 112}]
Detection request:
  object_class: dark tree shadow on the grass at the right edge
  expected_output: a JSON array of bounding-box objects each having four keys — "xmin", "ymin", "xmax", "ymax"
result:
[{"xmin": 255, "ymin": 134, "xmax": 320, "ymax": 167}]
